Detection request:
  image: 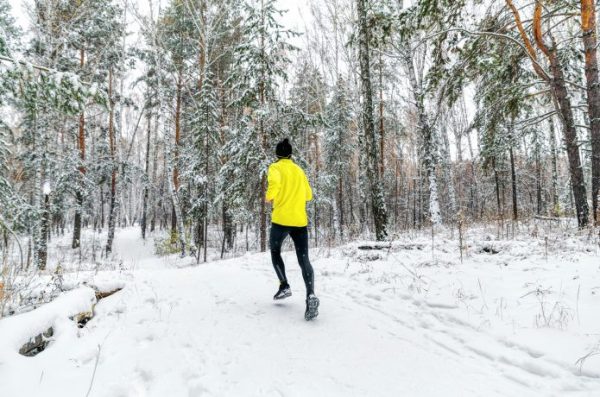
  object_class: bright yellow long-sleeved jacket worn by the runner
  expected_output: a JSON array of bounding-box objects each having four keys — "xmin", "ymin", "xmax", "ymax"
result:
[{"xmin": 266, "ymin": 159, "xmax": 312, "ymax": 227}]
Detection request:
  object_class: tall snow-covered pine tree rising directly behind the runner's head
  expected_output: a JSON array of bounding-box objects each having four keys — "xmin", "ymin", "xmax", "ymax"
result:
[{"xmin": 229, "ymin": 0, "xmax": 295, "ymax": 251}]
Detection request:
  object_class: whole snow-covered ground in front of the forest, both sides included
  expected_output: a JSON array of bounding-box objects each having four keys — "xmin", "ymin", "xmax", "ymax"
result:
[{"xmin": 0, "ymin": 224, "xmax": 600, "ymax": 397}]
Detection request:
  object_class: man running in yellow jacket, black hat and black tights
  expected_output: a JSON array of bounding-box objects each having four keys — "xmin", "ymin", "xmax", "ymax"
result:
[{"xmin": 265, "ymin": 139, "xmax": 319, "ymax": 321}]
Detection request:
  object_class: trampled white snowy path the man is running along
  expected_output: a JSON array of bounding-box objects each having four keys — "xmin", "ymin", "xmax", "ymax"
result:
[{"xmin": 0, "ymin": 227, "xmax": 600, "ymax": 397}]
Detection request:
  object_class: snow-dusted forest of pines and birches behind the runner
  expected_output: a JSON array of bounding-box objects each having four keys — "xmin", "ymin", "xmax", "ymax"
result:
[{"xmin": 0, "ymin": 0, "xmax": 600, "ymax": 269}]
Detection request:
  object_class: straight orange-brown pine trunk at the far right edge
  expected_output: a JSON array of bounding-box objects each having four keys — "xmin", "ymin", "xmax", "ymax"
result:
[{"xmin": 581, "ymin": 0, "xmax": 600, "ymax": 225}]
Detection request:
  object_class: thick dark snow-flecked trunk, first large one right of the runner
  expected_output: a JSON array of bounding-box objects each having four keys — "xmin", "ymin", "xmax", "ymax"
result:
[{"xmin": 357, "ymin": 0, "xmax": 387, "ymax": 241}]
